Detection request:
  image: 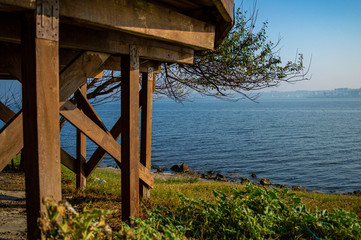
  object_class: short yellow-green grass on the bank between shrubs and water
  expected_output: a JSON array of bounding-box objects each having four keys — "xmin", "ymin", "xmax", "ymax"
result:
[{"xmin": 62, "ymin": 167, "xmax": 361, "ymax": 220}]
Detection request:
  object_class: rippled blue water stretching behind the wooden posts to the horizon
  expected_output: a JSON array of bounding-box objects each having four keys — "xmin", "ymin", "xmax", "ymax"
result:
[{"xmin": 61, "ymin": 99, "xmax": 361, "ymax": 192}]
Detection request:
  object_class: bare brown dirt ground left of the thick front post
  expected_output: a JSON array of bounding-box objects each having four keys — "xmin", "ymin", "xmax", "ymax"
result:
[{"xmin": 0, "ymin": 172, "xmax": 26, "ymax": 240}]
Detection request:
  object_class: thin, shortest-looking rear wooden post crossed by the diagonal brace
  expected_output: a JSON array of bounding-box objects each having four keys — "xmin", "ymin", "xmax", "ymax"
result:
[{"xmin": 76, "ymin": 84, "xmax": 88, "ymax": 190}]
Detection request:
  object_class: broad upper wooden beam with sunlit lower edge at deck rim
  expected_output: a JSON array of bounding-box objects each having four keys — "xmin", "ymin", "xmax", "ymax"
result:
[{"xmin": 60, "ymin": 0, "xmax": 215, "ymax": 50}]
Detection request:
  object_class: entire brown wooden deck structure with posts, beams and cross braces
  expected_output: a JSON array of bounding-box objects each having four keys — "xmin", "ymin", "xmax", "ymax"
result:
[{"xmin": 0, "ymin": 0, "xmax": 234, "ymax": 239}]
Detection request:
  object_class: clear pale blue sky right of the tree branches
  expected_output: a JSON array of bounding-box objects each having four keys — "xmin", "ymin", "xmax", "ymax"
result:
[{"xmin": 235, "ymin": 0, "xmax": 361, "ymax": 91}]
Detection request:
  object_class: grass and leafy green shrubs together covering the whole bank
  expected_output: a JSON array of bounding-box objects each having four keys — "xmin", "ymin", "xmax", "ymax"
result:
[{"xmin": 52, "ymin": 168, "xmax": 361, "ymax": 239}]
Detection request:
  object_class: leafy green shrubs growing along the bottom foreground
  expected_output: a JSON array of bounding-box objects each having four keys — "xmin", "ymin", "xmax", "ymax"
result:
[{"xmin": 42, "ymin": 184, "xmax": 361, "ymax": 239}]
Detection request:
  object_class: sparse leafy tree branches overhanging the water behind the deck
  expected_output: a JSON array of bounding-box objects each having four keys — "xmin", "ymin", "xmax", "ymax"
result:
[{"xmin": 88, "ymin": 8, "xmax": 307, "ymax": 103}]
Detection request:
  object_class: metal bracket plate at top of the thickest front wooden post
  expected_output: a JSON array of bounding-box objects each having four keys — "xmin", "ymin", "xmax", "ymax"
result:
[{"xmin": 36, "ymin": 0, "xmax": 59, "ymax": 41}]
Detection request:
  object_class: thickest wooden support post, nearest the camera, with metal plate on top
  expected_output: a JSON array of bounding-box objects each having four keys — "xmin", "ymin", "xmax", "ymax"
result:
[{"xmin": 21, "ymin": 0, "xmax": 61, "ymax": 239}]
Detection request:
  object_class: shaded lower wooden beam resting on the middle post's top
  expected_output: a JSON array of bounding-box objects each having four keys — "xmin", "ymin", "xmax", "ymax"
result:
[{"xmin": 60, "ymin": 23, "xmax": 194, "ymax": 64}]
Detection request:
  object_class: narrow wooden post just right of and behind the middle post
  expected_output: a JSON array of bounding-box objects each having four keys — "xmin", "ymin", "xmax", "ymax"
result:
[{"xmin": 139, "ymin": 67, "xmax": 154, "ymax": 198}]
